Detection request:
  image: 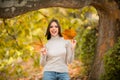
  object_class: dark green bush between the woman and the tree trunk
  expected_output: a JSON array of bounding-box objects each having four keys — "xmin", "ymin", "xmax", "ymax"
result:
[{"xmin": 76, "ymin": 27, "xmax": 97, "ymax": 76}]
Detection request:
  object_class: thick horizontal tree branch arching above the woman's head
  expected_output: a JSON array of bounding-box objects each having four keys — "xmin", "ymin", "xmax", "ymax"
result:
[{"xmin": 0, "ymin": 0, "xmax": 92, "ymax": 18}]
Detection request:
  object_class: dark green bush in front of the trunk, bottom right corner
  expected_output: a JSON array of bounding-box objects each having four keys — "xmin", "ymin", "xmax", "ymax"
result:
[{"xmin": 101, "ymin": 38, "xmax": 120, "ymax": 80}]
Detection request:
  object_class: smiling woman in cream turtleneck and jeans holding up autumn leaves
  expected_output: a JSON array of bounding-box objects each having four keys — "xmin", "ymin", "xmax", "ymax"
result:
[{"xmin": 40, "ymin": 19, "xmax": 76, "ymax": 80}]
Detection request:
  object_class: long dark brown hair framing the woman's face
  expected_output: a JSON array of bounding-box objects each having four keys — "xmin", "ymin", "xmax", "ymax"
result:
[{"xmin": 45, "ymin": 19, "xmax": 62, "ymax": 40}]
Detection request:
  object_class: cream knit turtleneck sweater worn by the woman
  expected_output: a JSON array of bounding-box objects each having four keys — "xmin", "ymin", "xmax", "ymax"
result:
[{"xmin": 40, "ymin": 36, "xmax": 74, "ymax": 72}]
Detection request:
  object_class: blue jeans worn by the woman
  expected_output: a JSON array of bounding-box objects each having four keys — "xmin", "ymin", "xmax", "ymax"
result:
[{"xmin": 43, "ymin": 71, "xmax": 70, "ymax": 80}]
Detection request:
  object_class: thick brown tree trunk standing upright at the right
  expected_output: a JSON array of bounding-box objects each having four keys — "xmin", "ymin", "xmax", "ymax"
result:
[{"xmin": 88, "ymin": 1, "xmax": 120, "ymax": 80}]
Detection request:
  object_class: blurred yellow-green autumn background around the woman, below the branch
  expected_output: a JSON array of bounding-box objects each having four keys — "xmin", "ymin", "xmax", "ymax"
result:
[{"xmin": 0, "ymin": 6, "xmax": 99, "ymax": 80}]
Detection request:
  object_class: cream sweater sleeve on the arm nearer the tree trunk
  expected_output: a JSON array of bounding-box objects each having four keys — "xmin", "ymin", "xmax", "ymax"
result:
[{"xmin": 66, "ymin": 41, "xmax": 74, "ymax": 64}]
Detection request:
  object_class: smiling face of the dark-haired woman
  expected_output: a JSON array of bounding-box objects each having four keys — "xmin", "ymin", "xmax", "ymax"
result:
[{"xmin": 50, "ymin": 22, "xmax": 58, "ymax": 36}]
